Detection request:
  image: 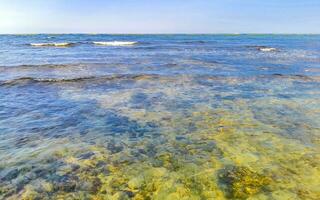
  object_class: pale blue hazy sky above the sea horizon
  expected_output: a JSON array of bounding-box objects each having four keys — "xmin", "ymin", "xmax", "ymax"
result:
[{"xmin": 0, "ymin": 0, "xmax": 320, "ymax": 34}]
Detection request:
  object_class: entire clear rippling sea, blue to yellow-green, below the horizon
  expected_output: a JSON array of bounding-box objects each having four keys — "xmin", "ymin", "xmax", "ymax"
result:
[{"xmin": 0, "ymin": 35, "xmax": 320, "ymax": 200}]
